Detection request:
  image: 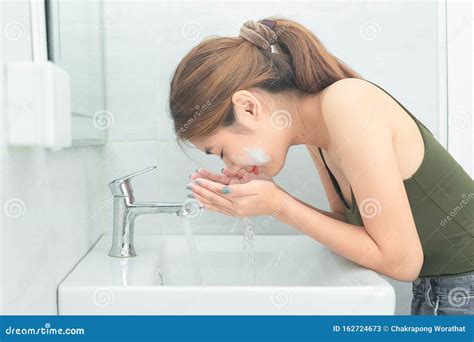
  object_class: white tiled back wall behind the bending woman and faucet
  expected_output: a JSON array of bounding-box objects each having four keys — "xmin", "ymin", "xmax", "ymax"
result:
[{"xmin": 102, "ymin": 0, "xmax": 452, "ymax": 314}]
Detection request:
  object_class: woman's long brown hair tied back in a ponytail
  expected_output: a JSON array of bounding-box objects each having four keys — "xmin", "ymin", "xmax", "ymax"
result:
[{"xmin": 169, "ymin": 17, "xmax": 361, "ymax": 147}]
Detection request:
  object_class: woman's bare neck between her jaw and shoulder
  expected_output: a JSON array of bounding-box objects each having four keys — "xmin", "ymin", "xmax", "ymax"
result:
[{"xmin": 291, "ymin": 92, "xmax": 329, "ymax": 150}]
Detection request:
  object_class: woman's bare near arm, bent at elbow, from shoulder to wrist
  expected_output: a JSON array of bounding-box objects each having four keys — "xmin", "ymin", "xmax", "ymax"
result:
[{"xmin": 276, "ymin": 79, "xmax": 423, "ymax": 281}]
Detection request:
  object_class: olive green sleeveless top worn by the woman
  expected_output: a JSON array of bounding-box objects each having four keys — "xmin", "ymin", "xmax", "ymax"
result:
[{"xmin": 319, "ymin": 81, "xmax": 474, "ymax": 277}]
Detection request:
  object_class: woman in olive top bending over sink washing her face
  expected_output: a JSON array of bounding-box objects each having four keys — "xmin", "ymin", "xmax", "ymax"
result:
[{"xmin": 170, "ymin": 18, "xmax": 474, "ymax": 315}]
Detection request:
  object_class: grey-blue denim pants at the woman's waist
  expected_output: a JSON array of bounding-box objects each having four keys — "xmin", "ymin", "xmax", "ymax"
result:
[{"xmin": 411, "ymin": 271, "xmax": 474, "ymax": 315}]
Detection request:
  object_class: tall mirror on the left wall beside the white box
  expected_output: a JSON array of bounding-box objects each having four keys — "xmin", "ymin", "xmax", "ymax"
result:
[{"xmin": 45, "ymin": 0, "xmax": 106, "ymax": 146}]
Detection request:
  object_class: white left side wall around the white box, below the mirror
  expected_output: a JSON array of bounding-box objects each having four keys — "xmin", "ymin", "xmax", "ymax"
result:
[{"xmin": 0, "ymin": 1, "xmax": 103, "ymax": 315}]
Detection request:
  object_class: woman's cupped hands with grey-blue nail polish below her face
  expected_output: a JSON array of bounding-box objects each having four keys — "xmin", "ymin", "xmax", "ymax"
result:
[{"xmin": 190, "ymin": 175, "xmax": 286, "ymax": 218}]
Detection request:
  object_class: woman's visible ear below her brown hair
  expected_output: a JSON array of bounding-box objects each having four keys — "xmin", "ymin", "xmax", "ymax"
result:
[{"xmin": 232, "ymin": 90, "xmax": 263, "ymax": 127}]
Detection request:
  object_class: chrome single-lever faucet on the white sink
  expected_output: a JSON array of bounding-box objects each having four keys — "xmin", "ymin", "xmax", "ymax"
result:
[{"xmin": 109, "ymin": 166, "xmax": 189, "ymax": 258}]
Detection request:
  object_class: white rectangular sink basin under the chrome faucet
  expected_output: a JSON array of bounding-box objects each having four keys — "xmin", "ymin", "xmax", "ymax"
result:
[{"xmin": 58, "ymin": 234, "xmax": 395, "ymax": 315}]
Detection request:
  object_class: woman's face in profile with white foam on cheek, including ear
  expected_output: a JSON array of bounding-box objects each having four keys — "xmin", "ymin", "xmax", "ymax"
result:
[{"xmin": 192, "ymin": 90, "xmax": 291, "ymax": 177}]
